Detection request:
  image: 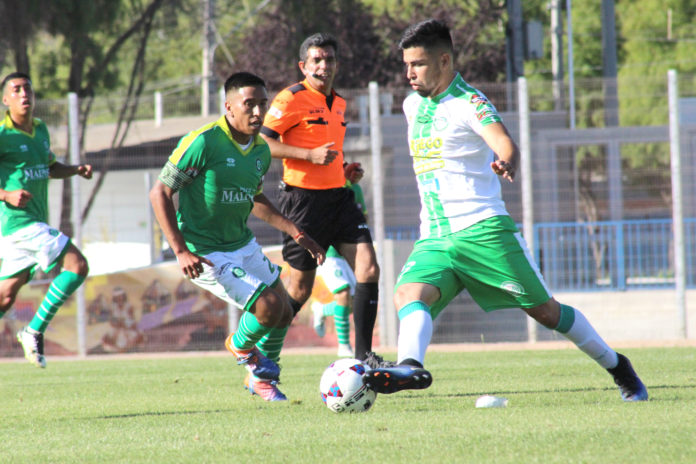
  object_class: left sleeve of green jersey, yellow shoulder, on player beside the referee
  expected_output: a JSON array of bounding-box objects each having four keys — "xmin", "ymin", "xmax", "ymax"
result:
[{"xmin": 159, "ymin": 134, "xmax": 205, "ymax": 191}]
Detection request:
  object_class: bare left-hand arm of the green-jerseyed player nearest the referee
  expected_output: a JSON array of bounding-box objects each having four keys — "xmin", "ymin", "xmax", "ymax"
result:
[{"xmin": 150, "ymin": 179, "xmax": 213, "ymax": 279}]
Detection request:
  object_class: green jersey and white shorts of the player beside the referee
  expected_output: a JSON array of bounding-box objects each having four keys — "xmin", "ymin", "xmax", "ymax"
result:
[{"xmin": 159, "ymin": 116, "xmax": 280, "ymax": 309}]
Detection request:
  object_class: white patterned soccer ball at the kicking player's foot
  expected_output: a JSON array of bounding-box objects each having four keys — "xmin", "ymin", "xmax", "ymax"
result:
[{"xmin": 319, "ymin": 358, "xmax": 377, "ymax": 412}]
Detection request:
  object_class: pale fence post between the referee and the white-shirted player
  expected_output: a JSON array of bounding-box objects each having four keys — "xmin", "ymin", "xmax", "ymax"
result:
[{"xmin": 368, "ymin": 81, "xmax": 396, "ymax": 346}]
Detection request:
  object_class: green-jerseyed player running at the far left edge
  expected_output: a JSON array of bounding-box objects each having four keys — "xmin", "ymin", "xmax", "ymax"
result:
[{"xmin": 0, "ymin": 72, "xmax": 92, "ymax": 367}]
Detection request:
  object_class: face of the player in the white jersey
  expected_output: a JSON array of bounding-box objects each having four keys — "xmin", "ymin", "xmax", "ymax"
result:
[{"xmin": 403, "ymin": 47, "xmax": 449, "ymax": 97}]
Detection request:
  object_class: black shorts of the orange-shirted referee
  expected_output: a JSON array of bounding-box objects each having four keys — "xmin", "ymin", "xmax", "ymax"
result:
[{"xmin": 278, "ymin": 185, "xmax": 372, "ymax": 271}]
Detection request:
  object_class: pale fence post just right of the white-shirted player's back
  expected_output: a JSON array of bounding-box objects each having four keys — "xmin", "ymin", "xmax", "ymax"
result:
[{"xmin": 517, "ymin": 77, "xmax": 538, "ymax": 343}]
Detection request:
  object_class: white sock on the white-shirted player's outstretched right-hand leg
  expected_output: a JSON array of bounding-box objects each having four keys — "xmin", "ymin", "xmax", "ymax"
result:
[{"xmin": 556, "ymin": 304, "xmax": 619, "ymax": 369}]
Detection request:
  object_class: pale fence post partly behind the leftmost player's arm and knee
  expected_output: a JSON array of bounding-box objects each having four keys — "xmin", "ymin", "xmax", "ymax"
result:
[{"xmin": 68, "ymin": 92, "xmax": 87, "ymax": 357}]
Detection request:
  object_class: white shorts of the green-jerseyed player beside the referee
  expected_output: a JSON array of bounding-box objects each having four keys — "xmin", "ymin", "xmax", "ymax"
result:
[{"xmin": 191, "ymin": 239, "xmax": 280, "ymax": 311}]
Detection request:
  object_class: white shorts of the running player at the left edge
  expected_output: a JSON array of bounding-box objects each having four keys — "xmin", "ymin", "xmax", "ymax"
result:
[{"xmin": 0, "ymin": 222, "xmax": 70, "ymax": 279}]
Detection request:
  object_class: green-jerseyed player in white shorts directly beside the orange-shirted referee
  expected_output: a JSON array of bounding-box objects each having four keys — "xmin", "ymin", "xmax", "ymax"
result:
[{"xmin": 150, "ymin": 72, "xmax": 325, "ymax": 401}]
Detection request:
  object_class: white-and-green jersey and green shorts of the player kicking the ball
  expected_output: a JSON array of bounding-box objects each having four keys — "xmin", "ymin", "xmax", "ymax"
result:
[{"xmin": 397, "ymin": 74, "xmax": 550, "ymax": 317}]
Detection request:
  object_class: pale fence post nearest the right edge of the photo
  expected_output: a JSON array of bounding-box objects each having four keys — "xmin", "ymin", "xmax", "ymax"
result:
[{"xmin": 667, "ymin": 69, "xmax": 688, "ymax": 338}]
